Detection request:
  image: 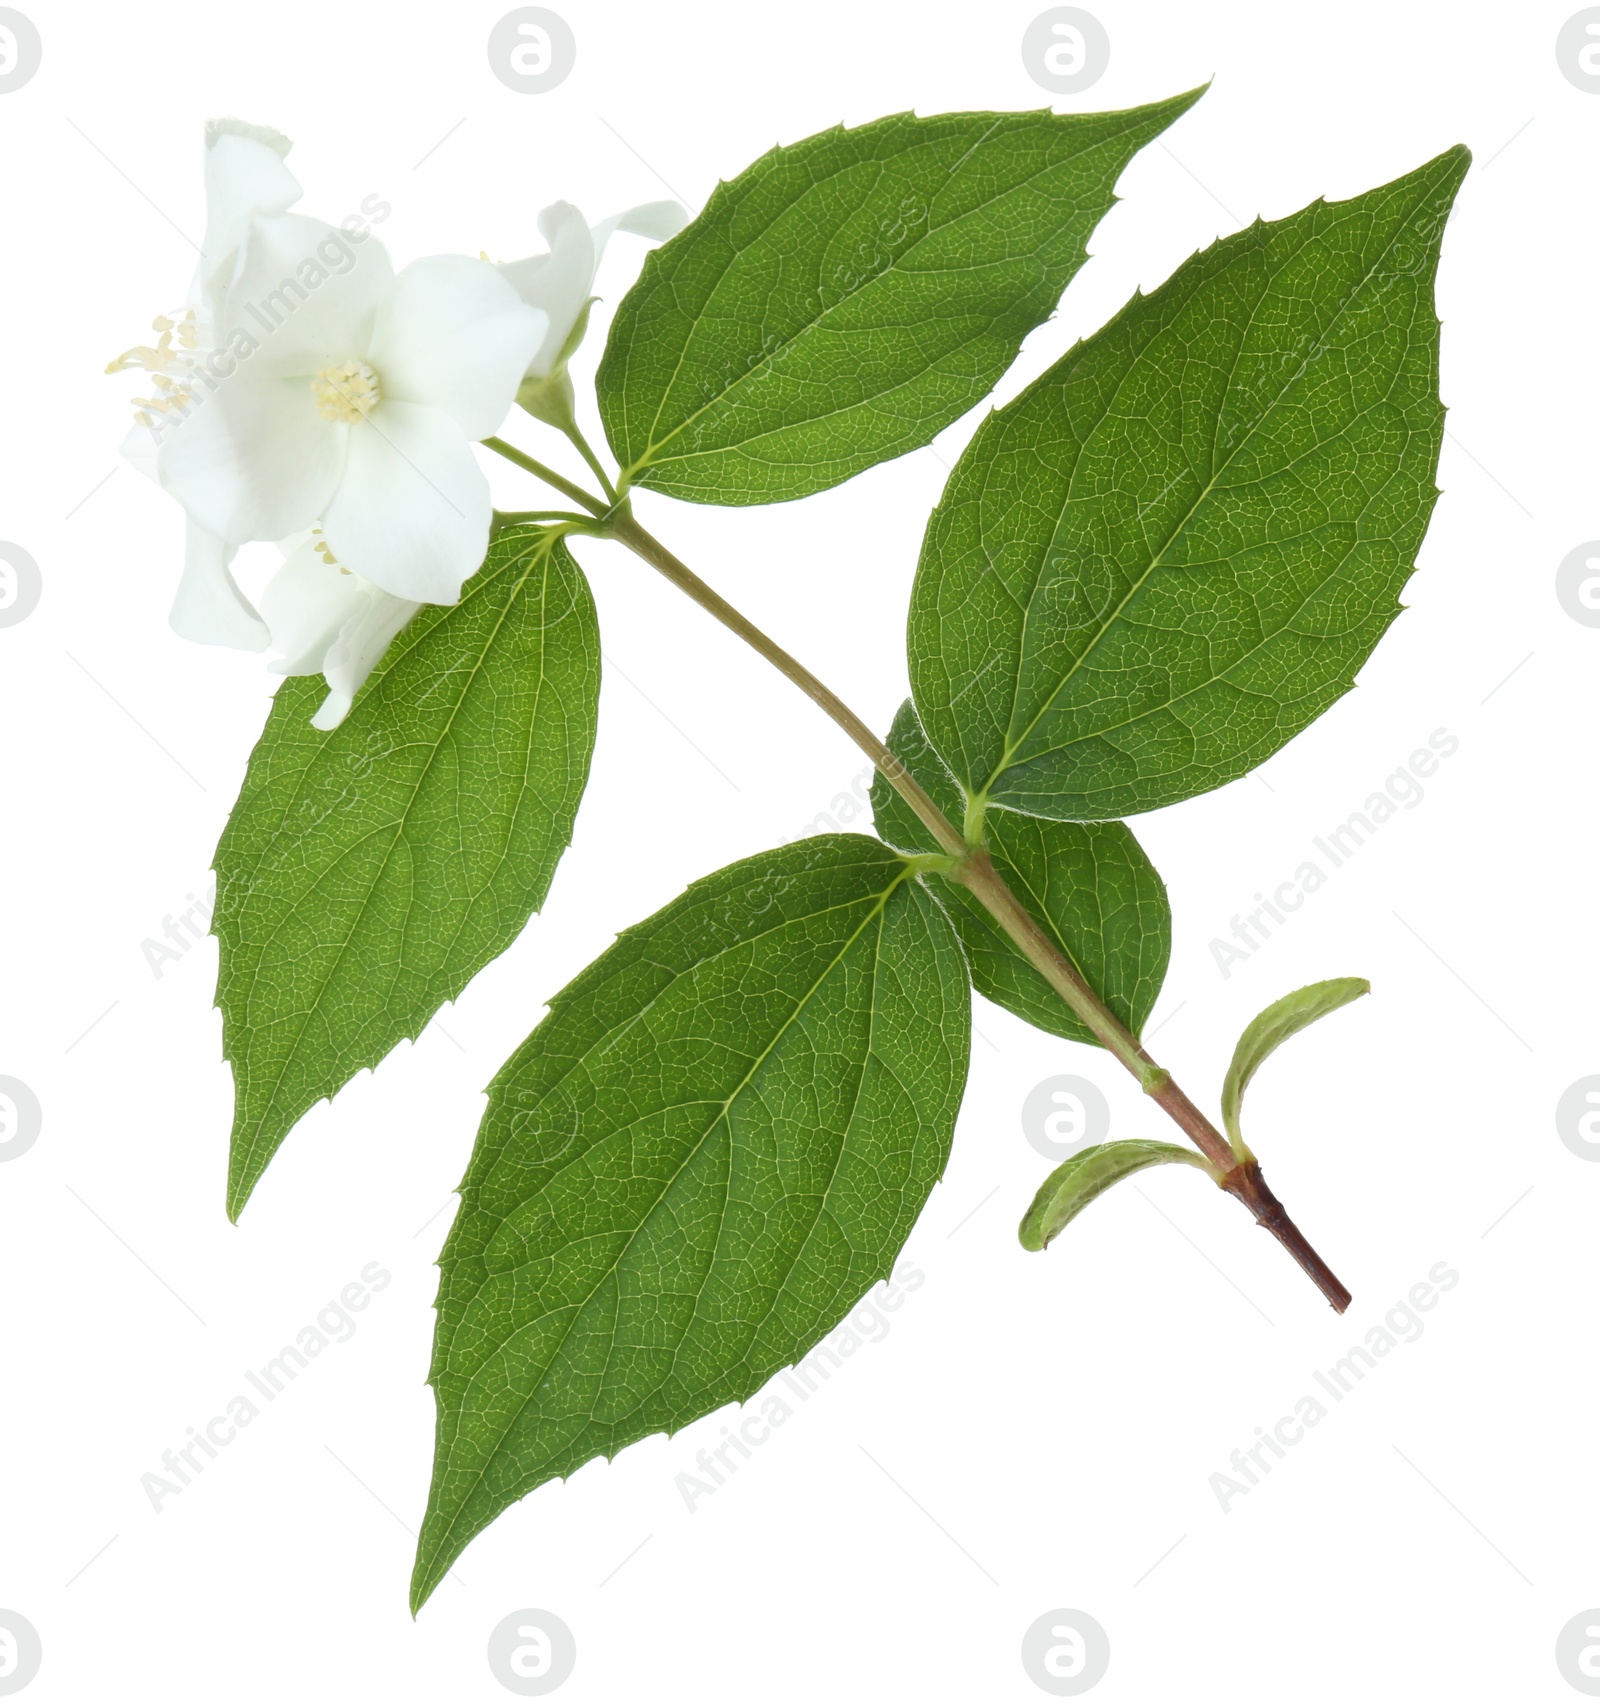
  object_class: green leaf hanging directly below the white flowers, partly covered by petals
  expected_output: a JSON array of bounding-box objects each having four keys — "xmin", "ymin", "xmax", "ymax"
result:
[{"xmin": 211, "ymin": 530, "xmax": 600, "ymax": 1218}]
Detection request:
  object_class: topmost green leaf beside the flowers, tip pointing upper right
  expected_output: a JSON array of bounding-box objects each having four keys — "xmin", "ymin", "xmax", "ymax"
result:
[{"xmin": 596, "ymin": 89, "xmax": 1201, "ymax": 503}]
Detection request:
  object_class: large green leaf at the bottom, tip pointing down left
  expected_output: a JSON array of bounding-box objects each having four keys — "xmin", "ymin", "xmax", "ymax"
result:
[{"xmin": 412, "ymin": 835, "xmax": 970, "ymax": 1607}]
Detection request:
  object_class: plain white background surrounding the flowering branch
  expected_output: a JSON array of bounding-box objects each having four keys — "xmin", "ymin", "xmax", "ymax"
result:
[{"xmin": 0, "ymin": 0, "xmax": 1600, "ymax": 1704}]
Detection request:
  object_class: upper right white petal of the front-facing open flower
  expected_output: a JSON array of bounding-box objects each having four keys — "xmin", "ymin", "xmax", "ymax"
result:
[{"xmin": 368, "ymin": 254, "xmax": 549, "ymax": 438}]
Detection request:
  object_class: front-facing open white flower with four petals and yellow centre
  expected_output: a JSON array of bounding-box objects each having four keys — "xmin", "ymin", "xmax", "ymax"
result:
[{"xmin": 157, "ymin": 213, "xmax": 547, "ymax": 603}]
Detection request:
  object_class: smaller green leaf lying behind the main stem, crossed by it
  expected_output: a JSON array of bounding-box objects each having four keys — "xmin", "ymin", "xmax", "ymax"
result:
[{"xmin": 872, "ymin": 700, "xmax": 1172, "ymax": 1045}]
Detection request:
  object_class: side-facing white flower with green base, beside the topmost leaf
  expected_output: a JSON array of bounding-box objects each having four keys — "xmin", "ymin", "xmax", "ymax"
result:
[{"xmin": 499, "ymin": 201, "xmax": 688, "ymax": 426}]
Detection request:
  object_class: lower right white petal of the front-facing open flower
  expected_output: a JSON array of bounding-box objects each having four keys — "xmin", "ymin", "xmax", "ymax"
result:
[{"xmin": 322, "ymin": 399, "xmax": 489, "ymax": 603}]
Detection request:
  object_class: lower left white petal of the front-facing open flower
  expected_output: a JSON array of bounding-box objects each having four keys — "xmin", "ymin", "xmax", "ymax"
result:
[{"xmin": 157, "ymin": 373, "xmax": 349, "ymax": 545}]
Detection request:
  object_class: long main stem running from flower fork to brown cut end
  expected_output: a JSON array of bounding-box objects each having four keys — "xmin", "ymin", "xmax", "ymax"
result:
[{"xmin": 605, "ymin": 513, "xmax": 1350, "ymax": 1314}]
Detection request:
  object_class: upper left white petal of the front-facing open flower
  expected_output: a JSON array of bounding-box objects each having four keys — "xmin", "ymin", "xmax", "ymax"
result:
[{"xmin": 215, "ymin": 213, "xmax": 394, "ymax": 377}]
